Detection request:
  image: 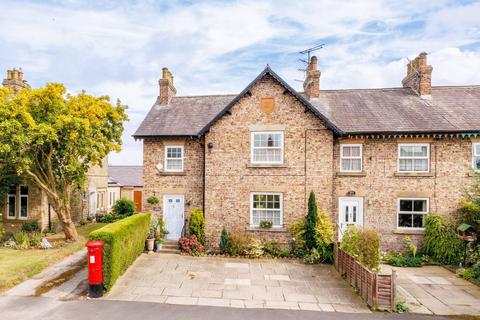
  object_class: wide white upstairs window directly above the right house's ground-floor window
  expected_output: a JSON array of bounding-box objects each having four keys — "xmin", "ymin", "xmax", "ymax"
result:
[{"xmin": 398, "ymin": 143, "xmax": 430, "ymax": 172}]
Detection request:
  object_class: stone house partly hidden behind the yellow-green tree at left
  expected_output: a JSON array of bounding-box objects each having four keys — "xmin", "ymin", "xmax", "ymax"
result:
[{"xmin": 0, "ymin": 69, "xmax": 108, "ymax": 231}]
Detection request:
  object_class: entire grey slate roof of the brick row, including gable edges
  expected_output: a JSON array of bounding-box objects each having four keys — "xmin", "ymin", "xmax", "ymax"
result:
[{"xmin": 133, "ymin": 66, "xmax": 480, "ymax": 139}]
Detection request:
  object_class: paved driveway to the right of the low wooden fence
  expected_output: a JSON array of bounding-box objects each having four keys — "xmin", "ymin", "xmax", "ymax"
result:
[{"xmin": 382, "ymin": 266, "xmax": 480, "ymax": 315}]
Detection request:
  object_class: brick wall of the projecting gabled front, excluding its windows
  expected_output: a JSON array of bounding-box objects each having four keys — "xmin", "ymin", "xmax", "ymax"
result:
[{"xmin": 205, "ymin": 76, "xmax": 333, "ymax": 246}]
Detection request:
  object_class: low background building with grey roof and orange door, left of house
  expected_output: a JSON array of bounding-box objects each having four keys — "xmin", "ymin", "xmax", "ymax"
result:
[{"xmin": 108, "ymin": 166, "xmax": 143, "ymax": 212}]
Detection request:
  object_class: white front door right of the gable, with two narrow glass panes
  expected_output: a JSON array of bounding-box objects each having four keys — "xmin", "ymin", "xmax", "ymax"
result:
[{"xmin": 338, "ymin": 197, "xmax": 363, "ymax": 241}]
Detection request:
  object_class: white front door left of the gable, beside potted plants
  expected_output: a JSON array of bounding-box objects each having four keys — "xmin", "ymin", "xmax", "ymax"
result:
[{"xmin": 163, "ymin": 195, "xmax": 184, "ymax": 240}]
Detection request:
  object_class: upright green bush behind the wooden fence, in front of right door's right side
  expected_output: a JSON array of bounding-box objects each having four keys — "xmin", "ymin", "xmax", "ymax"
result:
[{"xmin": 358, "ymin": 229, "xmax": 380, "ymax": 270}]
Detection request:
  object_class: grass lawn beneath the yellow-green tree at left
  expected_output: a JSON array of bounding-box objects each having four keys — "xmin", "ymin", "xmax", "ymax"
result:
[{"xmin": 0, "ymin": 223, "xmax": 105, "ymax": 292}]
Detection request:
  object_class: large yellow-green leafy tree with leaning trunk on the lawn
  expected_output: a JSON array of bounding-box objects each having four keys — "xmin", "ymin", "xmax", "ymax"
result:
[{"xmin": 0, "ymin": 83, "xmax": 128, "ymax": 240}]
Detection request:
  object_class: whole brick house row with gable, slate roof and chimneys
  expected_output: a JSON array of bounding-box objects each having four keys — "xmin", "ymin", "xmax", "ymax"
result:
[{"xmin": 134, "ymin": 53, "xmax": 480, "ymax": 249}]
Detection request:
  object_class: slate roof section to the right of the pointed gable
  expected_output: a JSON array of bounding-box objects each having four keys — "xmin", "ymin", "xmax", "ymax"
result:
[{"xmin": 310, "ymin": 86, "xmax": 480, "ymax": 134}]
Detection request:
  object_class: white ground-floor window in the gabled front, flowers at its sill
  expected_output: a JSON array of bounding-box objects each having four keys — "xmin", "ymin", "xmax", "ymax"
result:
[{"xmin": 250, "ymin": 192, "xmax": 283, "ymax": 227}]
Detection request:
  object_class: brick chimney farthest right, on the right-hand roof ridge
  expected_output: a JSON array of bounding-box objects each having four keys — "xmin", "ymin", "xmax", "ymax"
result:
[{"xmin": 402, "ymin": 52, "xmax": 433, "ymax": 98}]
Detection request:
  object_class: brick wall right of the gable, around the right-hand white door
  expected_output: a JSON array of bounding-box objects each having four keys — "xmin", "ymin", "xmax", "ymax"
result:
[{"xmin": 333, "ymin": 138, "xmax": 472, "ymax": 250}]
